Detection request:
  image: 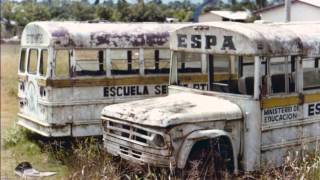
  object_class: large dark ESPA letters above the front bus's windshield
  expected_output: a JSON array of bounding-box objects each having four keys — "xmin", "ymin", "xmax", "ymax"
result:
[{"xmin": 177, "ymin": 34, "xmax": 236, "ymax": 50}]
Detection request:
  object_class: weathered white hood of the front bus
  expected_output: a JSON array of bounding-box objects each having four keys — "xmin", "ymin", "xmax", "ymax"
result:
[{"xmin": 102, "ymin": 93, "xmax": 242, "ymax": 127}]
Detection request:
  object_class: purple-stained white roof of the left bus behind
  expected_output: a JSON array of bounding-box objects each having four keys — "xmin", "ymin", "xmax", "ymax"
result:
[{"xmin": 21, "ymin": 21, "xmax": 186, "ymax": 48}]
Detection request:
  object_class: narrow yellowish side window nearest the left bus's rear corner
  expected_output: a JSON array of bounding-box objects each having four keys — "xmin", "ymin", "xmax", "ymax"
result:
[{"xmin": 55, "ymin": 50, "xmax": 70, "ymax": 77}]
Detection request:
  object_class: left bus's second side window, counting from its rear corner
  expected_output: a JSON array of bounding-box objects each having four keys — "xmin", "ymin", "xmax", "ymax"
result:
[{"xmin": 75, "ymin": 50, "xmax": 106, "ymax": 76}]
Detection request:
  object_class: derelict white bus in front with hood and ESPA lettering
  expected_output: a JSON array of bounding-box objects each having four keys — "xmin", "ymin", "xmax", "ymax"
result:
[{"xmin": 101, "ymin": 23, "xmax": 320, "ymax": 176}]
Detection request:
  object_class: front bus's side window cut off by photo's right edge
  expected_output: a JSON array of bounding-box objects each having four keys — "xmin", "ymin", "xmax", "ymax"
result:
[{"xmin": 302, "ymin": 58, "xmax": 320, "ymax": 90}]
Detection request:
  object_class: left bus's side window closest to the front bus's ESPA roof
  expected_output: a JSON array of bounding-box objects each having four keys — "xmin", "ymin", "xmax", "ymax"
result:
[{"xmin": 144, "ymin": 49, "xmax": 170, "ymax": 74}]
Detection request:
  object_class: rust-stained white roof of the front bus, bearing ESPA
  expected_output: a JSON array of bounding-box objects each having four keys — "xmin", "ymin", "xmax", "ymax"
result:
[{"xmin": 170, "ymin": 22, "xmax": 320, "ymax": 57}]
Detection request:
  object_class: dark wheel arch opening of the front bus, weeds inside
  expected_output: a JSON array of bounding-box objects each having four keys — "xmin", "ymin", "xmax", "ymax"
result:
[{"xmin": 182, "ymin": 140, "xmax": 227, "ymax": 180}]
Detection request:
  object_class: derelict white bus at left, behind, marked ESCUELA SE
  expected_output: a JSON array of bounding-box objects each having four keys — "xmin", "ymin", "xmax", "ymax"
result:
[{"xmin": 18, "ymin": 22, "xmax": 210, "ymax": 137}]
